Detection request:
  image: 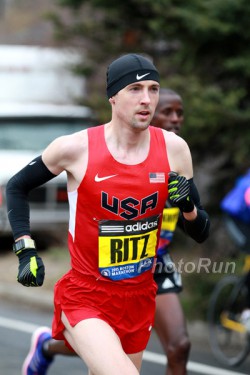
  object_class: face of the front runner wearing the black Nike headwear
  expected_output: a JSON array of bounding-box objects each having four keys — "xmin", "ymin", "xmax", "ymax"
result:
[{"xmin": 114, "ymin": 81, "xmax": 159, "ymax": 130}]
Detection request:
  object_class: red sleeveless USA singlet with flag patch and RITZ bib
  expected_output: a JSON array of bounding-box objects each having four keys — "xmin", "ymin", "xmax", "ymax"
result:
[{"xmin": 69, "ymin": 125, "xmax": 170, "ymax": 284}]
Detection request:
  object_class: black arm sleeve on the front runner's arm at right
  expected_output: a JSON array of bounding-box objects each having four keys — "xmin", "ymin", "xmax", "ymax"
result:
[{"xmin": 178, "ymin": 178, "xmax": 210, "ymax": 243}]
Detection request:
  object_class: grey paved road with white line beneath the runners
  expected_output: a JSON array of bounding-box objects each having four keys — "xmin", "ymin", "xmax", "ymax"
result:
[{"xmin": 0, "ymin": 299, "xmax": 250, "ymax": 375}]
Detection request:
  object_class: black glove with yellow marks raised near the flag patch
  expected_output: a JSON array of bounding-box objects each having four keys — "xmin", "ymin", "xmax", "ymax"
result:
[{"xmin": 168, "ymin": 172, "xmax": 194, "ymax": 212}]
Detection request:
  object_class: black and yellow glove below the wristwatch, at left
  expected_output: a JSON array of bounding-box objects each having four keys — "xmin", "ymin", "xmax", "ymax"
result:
[{"xmin": 17, "ymin": 249, "xmax": 45, "ymax": 286}]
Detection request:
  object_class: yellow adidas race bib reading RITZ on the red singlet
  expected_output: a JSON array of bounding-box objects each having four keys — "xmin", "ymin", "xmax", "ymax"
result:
[{"xmin": 98, "ymin": 216, "xmax": 159, "ymax": 280}]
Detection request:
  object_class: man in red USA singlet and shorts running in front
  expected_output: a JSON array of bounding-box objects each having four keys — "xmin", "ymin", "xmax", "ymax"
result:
[{"xmin": 7, "ymin": 54, "xmax": 208, "ymax": 375}]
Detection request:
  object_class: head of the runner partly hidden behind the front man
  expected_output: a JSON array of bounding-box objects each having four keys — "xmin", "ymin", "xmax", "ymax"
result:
[{"xmin": 152, "ymin": 94, "xmax": 184, "ymax": 134}]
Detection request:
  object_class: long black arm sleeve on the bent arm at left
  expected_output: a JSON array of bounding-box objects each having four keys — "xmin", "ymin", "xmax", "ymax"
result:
[{"xmin": 6, "ymin": 156, "xmax": 56, "ymax": 239}]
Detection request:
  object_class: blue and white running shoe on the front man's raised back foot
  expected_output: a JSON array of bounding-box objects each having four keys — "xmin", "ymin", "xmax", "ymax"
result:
[{"xmin": 22, "ymin": 327, "xmax": 53, "ymax": 375}]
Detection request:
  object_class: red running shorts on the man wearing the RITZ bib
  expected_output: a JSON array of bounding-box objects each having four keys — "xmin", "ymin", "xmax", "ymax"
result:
[{"xmin": 52, "ymin": 270, "xmax": 157, "ymax": 354}]
